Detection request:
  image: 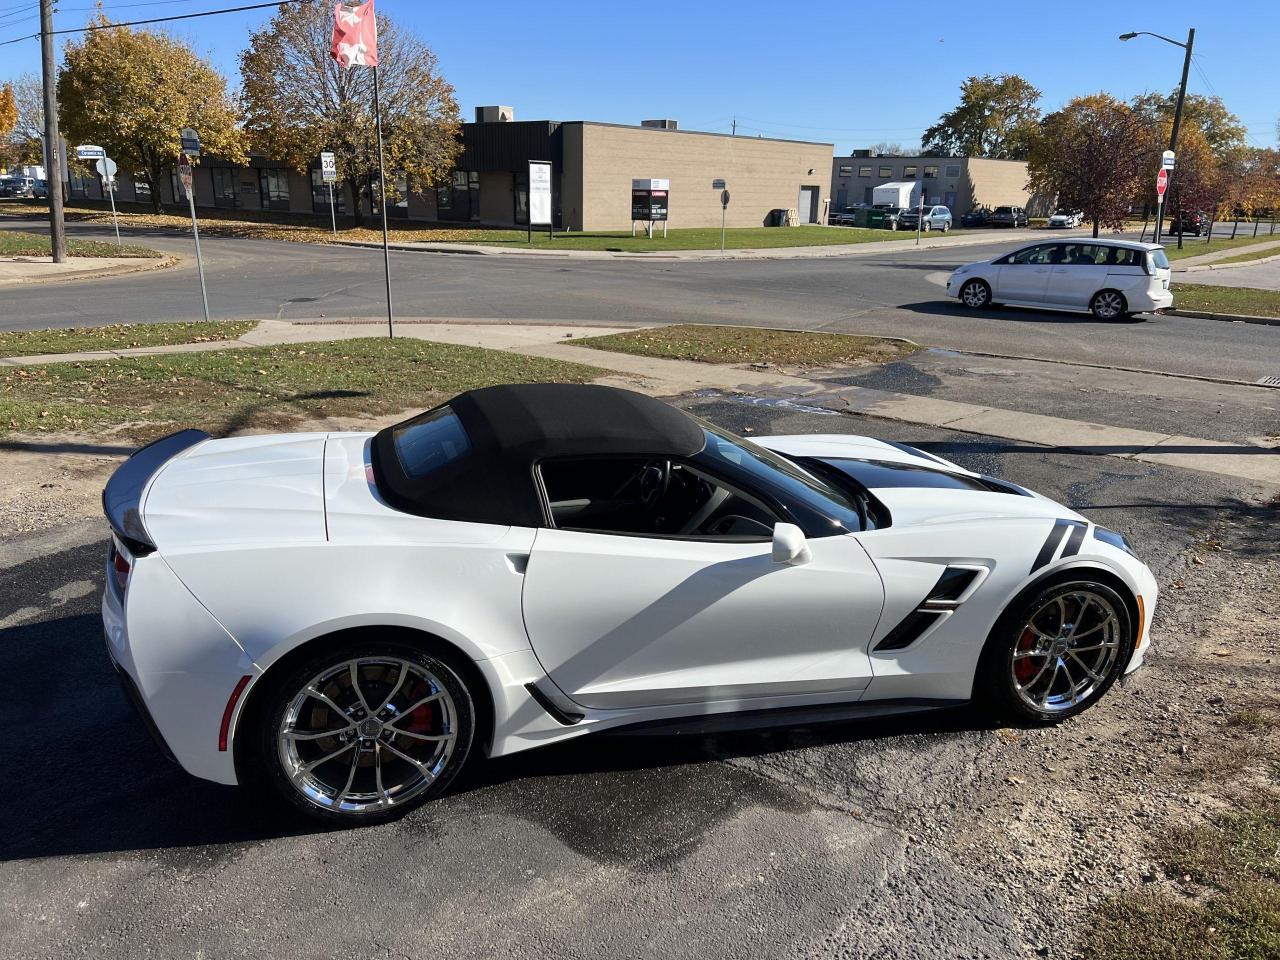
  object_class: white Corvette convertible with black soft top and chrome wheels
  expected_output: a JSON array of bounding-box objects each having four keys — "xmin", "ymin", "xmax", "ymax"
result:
[{"xmin": 102, "ymin": 384, "xmax": 1156, "ymax": 823}]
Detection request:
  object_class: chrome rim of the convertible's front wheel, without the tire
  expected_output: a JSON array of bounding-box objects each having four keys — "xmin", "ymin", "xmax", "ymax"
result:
[{"xmin": 1010, "ymin": 589, "xmax": 1124, "ymax": 713}]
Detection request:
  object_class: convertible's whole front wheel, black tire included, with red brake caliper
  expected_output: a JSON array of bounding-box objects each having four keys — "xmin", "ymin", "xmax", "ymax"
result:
[{"xmin": 978, "ymin": 579, "xmax": 1134, "ymax": 723}]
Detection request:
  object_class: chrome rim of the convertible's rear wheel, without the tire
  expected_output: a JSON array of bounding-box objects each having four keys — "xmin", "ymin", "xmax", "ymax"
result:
[{"xmin": 276, "ymin": 657, "xmax": 458, "ymax": 814}]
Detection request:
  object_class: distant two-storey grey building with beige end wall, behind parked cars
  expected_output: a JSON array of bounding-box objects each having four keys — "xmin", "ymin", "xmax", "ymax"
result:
[{"xmin": 831, "ymin": 151, "xmax": 1050, "ymax": 216}]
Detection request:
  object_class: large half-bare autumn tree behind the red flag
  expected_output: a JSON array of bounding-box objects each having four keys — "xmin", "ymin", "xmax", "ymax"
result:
[{"xmin": 241, "ymin": 0, "xmax": 461, "ymax": 227}]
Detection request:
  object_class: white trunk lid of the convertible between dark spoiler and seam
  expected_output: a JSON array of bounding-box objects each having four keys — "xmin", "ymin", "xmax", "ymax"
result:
[{"xmin": 142, "ymin": 433, "xmax": 326, "ymax": 550}]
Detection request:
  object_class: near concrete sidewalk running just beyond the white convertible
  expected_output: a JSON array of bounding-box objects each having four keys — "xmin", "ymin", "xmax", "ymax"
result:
[{"xmin": 0, "ymin": 320, "xmax": 1280, "ymax": 489}]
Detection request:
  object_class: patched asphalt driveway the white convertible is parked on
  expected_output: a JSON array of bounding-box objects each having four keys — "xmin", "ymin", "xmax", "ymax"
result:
[{"xmin": 0, "ymin": 398, "xmax": 1275, "ymax": 960}]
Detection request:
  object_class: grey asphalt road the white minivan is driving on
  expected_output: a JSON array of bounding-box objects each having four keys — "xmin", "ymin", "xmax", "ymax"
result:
[{"xmin": 0, "ymin": 223, "xmax": 1280, "ymax": 383}]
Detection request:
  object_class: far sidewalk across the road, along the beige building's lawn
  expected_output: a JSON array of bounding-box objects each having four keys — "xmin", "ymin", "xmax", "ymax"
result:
[{"xmin": 330, "ymin": 227, "xmax": 1085, "ymax": 260}]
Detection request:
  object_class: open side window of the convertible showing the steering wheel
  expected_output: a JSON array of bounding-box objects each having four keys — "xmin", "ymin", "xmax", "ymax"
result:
[{"xmin": 538, "ymin": 457, "xmax": 777, "ymax": 540}]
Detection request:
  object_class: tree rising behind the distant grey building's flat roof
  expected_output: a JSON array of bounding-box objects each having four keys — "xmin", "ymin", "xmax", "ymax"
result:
[{"xmin": 922, "ymin": 74, "xmax": 1041, "ymax": 160}]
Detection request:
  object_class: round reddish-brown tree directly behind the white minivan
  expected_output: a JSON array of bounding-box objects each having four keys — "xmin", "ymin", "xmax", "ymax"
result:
[{"xmin": 1027, "ymin": 93, "xmax": 1156, "ymax": 237}]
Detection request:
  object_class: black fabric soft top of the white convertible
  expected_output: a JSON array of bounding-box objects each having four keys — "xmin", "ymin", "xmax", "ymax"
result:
[{"xmin": 372, "ymin": 384, "xmax": 707, "ymax": 526}]
